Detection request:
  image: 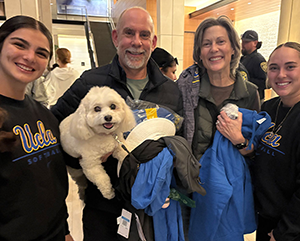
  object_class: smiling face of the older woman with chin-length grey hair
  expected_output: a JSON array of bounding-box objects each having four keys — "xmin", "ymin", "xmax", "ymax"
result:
[{"xmin": 200, "ymin": 26, "xmax": 234, "ymax": 75}]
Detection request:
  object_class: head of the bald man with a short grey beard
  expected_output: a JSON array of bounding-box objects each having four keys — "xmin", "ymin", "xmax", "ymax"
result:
[{"xmin": 112, "ymin": 8, "xmax": 157, "ymax": 77}]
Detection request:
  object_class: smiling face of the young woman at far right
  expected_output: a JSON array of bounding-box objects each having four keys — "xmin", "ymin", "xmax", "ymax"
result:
[{"xmin": 268, "ymin": 46, "xmax": 300, "ymax": 106}]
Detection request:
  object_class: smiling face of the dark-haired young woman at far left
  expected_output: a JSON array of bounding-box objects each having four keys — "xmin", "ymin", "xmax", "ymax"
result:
[{"xmin": 0, "ymin": 28, "xmax": 50, "ymax": 98}]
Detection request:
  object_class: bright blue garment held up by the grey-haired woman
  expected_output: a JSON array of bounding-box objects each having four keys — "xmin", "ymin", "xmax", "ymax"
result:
[{"xmin": 189, "ymin": 108, "xmax": 271, "ymax": 241}]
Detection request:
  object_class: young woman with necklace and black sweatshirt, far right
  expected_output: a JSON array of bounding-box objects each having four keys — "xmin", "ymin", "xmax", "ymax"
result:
[{"xmin": 253, "ymin": 42, "xmax": 300, "ymax": 241}]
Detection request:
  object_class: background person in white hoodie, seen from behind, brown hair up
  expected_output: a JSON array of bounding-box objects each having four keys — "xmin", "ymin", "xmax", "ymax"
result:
[{"xmin": 45, "ymin": 48, "xmax": 80, "ymax": 107}]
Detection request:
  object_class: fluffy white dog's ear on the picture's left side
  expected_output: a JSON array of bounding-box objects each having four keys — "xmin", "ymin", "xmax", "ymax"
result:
[{"xmin": 70, "ymin": 101, "xmax": 95, "ymax": 140}]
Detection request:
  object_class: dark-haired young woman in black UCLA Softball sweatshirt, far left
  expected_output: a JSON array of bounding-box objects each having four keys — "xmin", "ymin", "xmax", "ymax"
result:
[{"xmin": 0, "ymin": 15, "xmax": 73, "ymax": 241}]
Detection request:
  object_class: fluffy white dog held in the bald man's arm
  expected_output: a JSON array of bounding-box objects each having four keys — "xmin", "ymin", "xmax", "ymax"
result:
[{"xmin": 59, "ymin": 87, "xmax": 136, "ymax": 199}]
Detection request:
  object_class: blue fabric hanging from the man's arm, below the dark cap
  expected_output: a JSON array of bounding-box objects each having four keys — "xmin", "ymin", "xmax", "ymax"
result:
[{"xmin": 131, "ymin": 147, "xmax": 184, "ymax": 241}]
